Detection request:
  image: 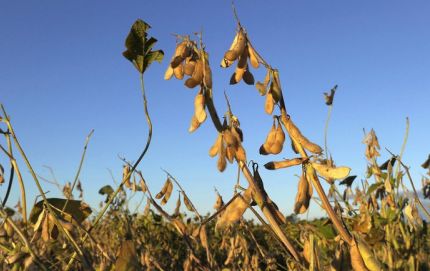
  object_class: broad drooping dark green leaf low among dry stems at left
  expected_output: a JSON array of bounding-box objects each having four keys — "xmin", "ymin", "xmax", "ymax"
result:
[{"xmin": 30, "ymin": 198, "xmax": 92, "ymax": 224}]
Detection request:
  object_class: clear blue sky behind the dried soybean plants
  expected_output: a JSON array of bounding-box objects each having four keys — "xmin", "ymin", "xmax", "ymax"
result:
[{"xmin": 0, "ymin": 1, "xmax": 430, "ymax": 220}]
